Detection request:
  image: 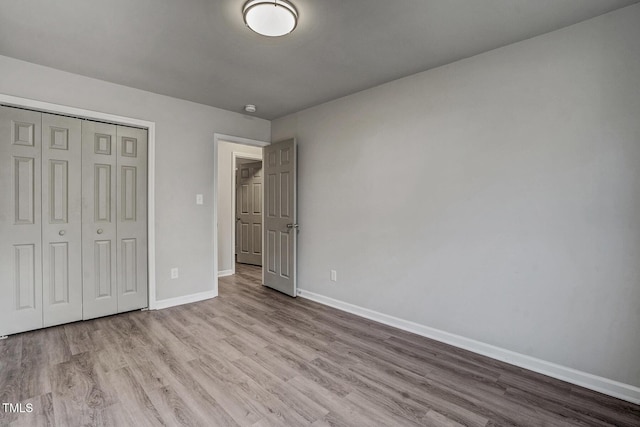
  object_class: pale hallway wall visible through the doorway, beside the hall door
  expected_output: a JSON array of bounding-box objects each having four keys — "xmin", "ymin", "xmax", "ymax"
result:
[{"xmin": 218, "ymin": 140, "xmax": 267, "ymax": 271}]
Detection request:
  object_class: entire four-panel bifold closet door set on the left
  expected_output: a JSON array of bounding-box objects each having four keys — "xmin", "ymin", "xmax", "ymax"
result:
[{"xmin": 0, "ymin": 106, "xmax": 147, "ymax": 335}]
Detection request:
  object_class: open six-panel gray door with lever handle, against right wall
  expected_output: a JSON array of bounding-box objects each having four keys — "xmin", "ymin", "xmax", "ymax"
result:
[{"xmin": 262, "ymin": 139, "xmax": 298, "ymax": 297}]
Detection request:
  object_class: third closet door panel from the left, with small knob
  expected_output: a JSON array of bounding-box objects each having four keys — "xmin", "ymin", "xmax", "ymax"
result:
[{"xmin": 82, "ymin": 121, "xmax": 118, "ymax": 319}]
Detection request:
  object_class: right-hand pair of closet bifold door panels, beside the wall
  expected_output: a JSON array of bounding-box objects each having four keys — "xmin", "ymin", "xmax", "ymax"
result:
[{"xmin": 82, "ymin": 122, "xmax": 147, "ymax": 319}]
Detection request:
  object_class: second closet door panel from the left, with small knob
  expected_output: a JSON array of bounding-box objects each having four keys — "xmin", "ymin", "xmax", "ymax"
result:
[{"xmin": 42, "ymin": 114, "xmax": 82, "ymax": 326}]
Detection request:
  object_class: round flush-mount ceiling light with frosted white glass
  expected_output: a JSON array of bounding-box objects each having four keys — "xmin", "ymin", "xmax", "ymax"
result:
[{"xmin": 242, "ymin": 0, "xmax": 298, "ymax": 37}]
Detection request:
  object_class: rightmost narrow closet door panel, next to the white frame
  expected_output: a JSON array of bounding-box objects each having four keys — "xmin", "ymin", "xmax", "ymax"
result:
[{"xmin": 116, "ymin": 126, "xmax": 148, "ymax": 313}]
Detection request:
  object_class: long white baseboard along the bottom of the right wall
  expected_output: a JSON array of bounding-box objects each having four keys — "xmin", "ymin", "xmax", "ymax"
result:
[{"xmin": 298, "ymin": 289, "xmax": 640, "ymax": 404}]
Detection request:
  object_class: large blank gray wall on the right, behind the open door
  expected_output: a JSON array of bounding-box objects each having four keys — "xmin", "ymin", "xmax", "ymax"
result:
[{"xmin": 272, "ymin": 5, "xmax": 640, "ymax": 386}]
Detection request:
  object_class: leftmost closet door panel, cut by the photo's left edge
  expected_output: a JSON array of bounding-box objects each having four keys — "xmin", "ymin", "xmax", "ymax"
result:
[{"xmin": 0, "ymin": 107, "xmax": 43, "ymax": 335}]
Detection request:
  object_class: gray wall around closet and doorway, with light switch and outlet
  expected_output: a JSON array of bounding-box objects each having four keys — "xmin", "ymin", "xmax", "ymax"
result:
[{"xmin": 0, "ymin": 56, "xmax": 270, "ymax": 300}]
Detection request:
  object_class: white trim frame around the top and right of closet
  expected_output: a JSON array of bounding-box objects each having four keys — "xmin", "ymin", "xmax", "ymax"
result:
[{"xmin": 0, "ymin": 93, "xmax": 159, "ymax": 310}]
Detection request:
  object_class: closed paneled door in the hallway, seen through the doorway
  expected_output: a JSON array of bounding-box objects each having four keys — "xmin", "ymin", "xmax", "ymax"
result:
[{"xmin": 236, "ymin": 161, "xmax": 262, "ymax": 265}]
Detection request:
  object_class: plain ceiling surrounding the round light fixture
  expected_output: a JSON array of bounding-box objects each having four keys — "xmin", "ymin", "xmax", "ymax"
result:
[{"xmin": 0, "ymin": 0, "xmax": 639, "ymax": 119}]
